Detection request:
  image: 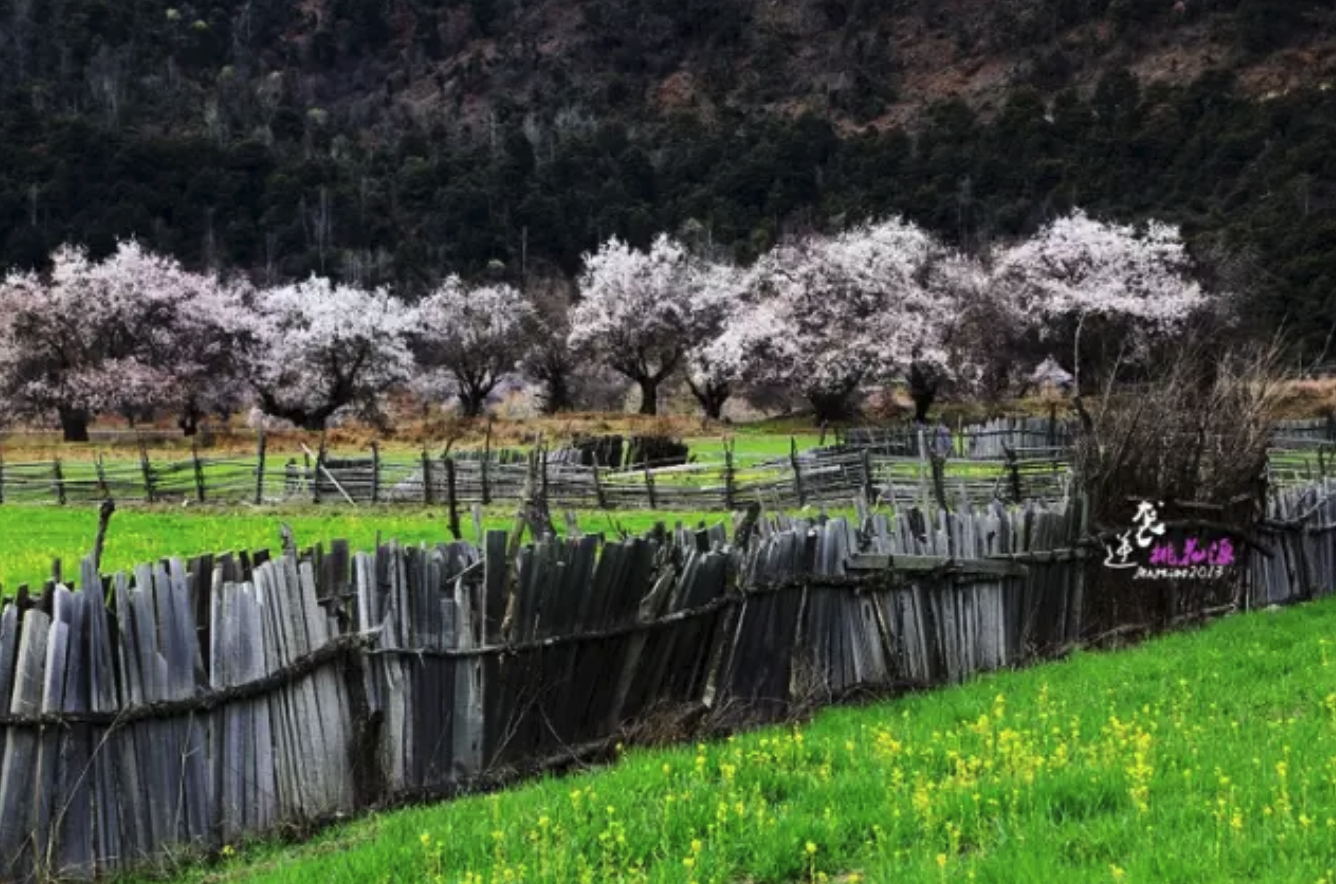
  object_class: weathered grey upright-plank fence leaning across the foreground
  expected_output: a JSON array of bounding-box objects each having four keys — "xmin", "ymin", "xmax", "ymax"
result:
[{"xmin": 0, "ymin": 483, "xmax": 1336, "ymax": 881}]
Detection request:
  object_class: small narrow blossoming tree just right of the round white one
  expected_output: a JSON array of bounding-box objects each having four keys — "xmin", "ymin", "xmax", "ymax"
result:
[{"xmin": 413, "ymin": 276, "xmax": 538, "ymax": 417}]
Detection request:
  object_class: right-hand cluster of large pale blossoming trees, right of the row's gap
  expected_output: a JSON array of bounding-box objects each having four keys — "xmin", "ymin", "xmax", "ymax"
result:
[{"xmin": 570, "ymin": 212, "xmax": 1222, "ymax": 419}]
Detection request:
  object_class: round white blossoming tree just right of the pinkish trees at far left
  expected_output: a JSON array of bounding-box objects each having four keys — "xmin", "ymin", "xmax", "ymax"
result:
[{"xmin": 239, "ymin": 276, "xmax": 417, "ymax": 430}]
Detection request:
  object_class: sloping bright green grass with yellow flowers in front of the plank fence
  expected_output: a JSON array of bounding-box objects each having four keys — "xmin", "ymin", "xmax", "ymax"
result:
[{"xmin": 125, "ymin": 600, "xmax": 1336, "ymax": 884}]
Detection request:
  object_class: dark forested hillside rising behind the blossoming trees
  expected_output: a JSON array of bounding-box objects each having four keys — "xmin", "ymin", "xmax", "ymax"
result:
[{"xmin": 0, "ymin": 0, "xmax": 1336, "ymax": 351}]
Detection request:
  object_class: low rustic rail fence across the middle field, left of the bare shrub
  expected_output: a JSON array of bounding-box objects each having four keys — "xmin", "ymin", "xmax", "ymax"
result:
[{"xmin": 0, "ymin": 442, "xmax": 1067, "ymax": 511}]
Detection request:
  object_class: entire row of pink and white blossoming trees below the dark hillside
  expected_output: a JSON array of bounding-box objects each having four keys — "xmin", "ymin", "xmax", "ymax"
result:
[{"xmin": 0, "ymin": 212, "xmax": 1206, "ymax": 441}]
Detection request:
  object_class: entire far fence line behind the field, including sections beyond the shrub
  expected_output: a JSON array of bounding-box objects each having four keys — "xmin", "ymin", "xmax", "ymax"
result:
[{"xmin": 0, "ymin": 415, "xmax": 1336, "ymax": 511}]
